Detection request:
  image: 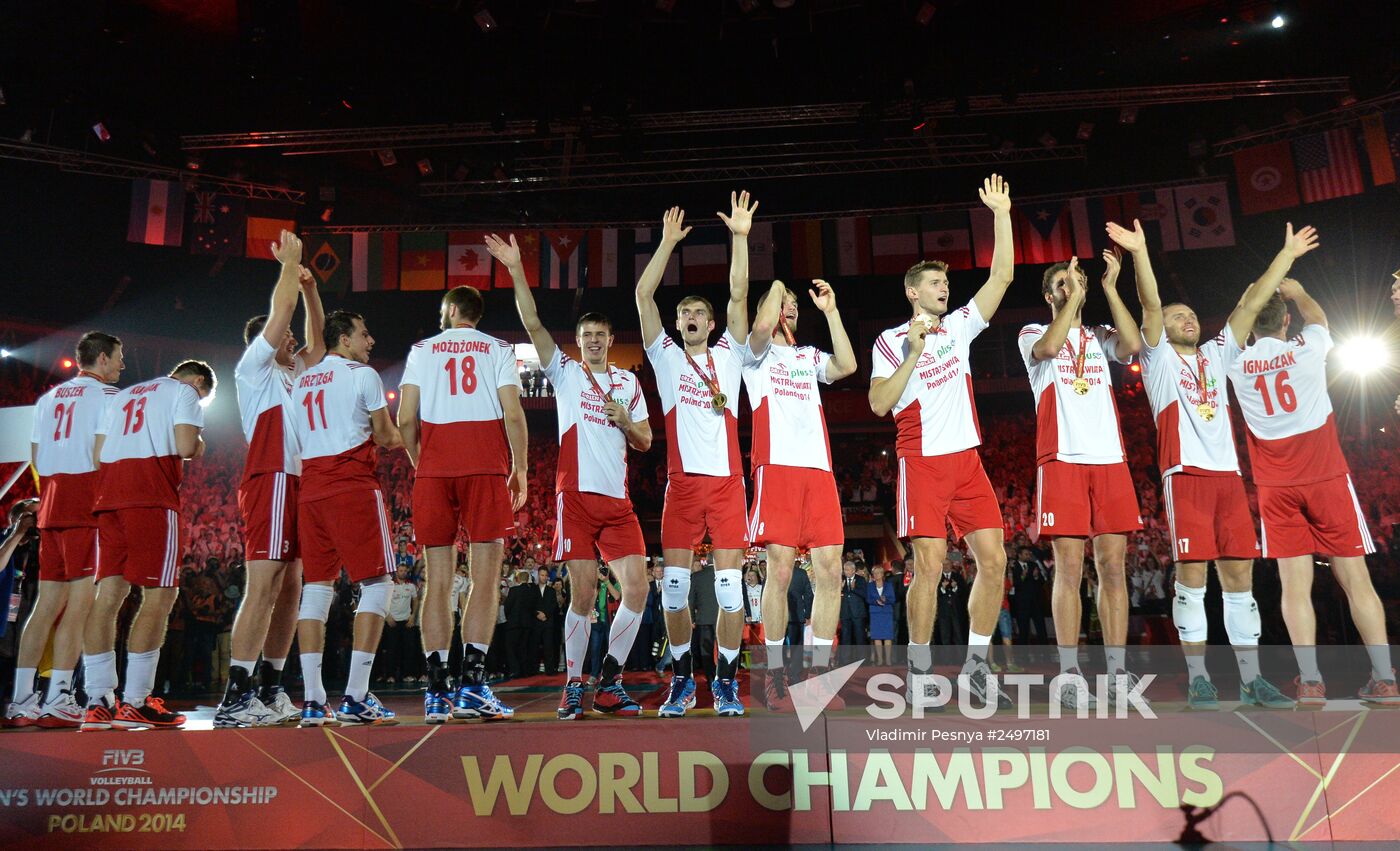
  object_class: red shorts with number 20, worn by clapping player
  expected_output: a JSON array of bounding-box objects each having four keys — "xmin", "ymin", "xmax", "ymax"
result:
[{"xmin": 1030, "ymin": 460, "xmax": 1142, "ymax": 540}]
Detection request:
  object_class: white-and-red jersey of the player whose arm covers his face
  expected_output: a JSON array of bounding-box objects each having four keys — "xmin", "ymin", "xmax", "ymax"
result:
[{"xmin": 743, "ymin": 342, "xmax": 832, "ymax": 472}]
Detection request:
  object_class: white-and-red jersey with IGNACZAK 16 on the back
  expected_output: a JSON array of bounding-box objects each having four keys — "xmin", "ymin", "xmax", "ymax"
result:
[{"xmin": 1229, "ymin": 325, "xmax": 1348, "ymax": 486}]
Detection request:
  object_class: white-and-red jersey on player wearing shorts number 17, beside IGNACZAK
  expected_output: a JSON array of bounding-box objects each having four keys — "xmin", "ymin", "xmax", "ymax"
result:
[{"xmin": 1141, "ymin": 323, "xmax": 1240, "ymax": 476}]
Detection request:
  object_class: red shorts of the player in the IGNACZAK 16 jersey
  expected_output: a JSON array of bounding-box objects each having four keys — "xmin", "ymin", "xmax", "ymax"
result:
[{"xmin": 1256, "ymin": 476, "xmax": 1376, "ymax": 558}]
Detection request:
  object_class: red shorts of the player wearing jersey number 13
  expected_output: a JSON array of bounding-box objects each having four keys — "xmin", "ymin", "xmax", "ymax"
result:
[{"xmin": 97, "ymin": 508, "xmax": 188, "ymax": 588}]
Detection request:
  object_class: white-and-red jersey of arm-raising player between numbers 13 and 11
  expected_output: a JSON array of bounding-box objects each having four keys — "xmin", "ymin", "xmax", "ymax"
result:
[{"xmin": 234, "ymin": 335, "xmax": 307, "ymax": 481}]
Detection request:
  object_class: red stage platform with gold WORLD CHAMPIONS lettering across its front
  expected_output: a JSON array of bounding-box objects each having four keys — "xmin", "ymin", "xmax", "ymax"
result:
[{"xmin": 0, "ymin": 676, "xmax": 1400, "ymax": 850}]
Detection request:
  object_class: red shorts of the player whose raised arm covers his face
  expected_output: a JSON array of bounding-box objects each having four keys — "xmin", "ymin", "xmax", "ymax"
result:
[{"xmin": 749, "ymin": 463, "xmax": 846, "ymax": 549}]
